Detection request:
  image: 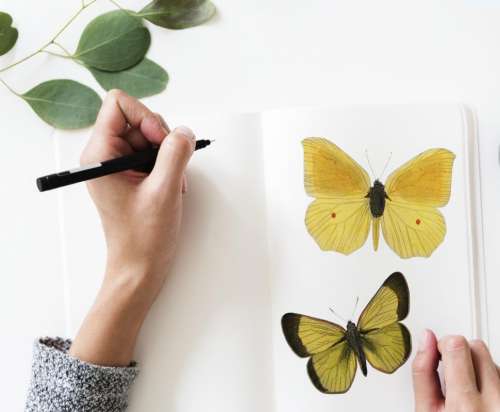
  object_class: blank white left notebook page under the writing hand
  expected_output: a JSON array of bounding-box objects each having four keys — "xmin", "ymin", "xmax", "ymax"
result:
[{"xmin": 53, "ymin": 115, "xmax": 272, "ymax": 412}]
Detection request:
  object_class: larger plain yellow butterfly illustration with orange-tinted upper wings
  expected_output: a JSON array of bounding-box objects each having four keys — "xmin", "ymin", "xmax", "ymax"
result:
[{"xmin": 302, "ymin": 138, "xmax": 455, "ymax": 258}]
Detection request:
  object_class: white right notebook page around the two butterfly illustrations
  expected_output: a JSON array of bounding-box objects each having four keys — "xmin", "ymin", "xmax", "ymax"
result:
[{"xmin": 263, "ymin": 105, "xmax": 474, "ymax": 412}]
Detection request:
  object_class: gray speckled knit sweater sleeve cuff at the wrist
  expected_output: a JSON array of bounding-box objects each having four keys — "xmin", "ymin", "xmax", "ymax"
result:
[{"xmin": 25, "ymin": 338, "xmax": 139, "ymax": 412}]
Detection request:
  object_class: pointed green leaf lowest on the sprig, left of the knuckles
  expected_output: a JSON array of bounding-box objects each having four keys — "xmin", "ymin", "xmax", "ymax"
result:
[{"xmin": 20, "ymin": 79, "xmax": 102, "ymax": 129}]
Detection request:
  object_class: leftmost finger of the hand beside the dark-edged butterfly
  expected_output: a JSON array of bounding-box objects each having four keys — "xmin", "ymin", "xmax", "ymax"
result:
[{"xmin": 412, "ymin": 329, "xmax": 443, "ymax": 412}]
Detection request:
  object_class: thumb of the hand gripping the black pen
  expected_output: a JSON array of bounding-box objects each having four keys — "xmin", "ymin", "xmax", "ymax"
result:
[{"xmin": 148, "ymin": 126, "xmax": 195, "ymax": 193}]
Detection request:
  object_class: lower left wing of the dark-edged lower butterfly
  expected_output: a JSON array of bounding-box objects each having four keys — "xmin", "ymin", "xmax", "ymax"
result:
[{"xmin": 307, "ymin": 341, "xmax": 357, "ymax": 393}]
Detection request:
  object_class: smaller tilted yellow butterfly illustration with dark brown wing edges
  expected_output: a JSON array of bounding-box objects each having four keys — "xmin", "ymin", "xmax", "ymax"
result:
[{"xmin": 281, "ymin": 272, "xmax": 411, "ymax": 393}]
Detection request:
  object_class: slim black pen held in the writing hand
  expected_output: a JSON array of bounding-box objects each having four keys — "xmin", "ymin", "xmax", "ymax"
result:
[{"xmin": 36, "ymin": 140, "xmax": 213, "ymax": 192}]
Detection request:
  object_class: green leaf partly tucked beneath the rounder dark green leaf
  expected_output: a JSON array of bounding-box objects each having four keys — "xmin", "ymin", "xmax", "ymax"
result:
[{"xmin": 88, "ymin": 58, "xmax": 168, "ymax": 98}]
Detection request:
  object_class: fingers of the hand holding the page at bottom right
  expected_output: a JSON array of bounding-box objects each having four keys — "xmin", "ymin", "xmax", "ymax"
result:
[{"xmin": 412, "ymin": 330, "xmax": 500, "ymax": 412}]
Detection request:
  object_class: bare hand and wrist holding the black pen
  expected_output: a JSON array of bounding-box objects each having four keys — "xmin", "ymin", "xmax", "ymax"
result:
[{"xmin": 71, "ymin": 90, "xmax": 195, "ymax": 365}]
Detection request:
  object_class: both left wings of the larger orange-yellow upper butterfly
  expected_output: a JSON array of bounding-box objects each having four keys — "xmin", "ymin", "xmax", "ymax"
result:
[{"xmin": 302, "ymin": 138, "xmax": 371, "ymax": 255}]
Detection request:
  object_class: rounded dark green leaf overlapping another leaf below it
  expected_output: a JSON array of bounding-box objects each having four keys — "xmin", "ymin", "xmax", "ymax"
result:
[{"xmin": 73, "ymin": 10, "xmax": 151, "ymax": 72}]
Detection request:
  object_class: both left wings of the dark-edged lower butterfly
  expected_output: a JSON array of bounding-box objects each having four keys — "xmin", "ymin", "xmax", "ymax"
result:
[{"xmin": 281, "ymin": 313, "xmax": 356, "ymax": 393}]
